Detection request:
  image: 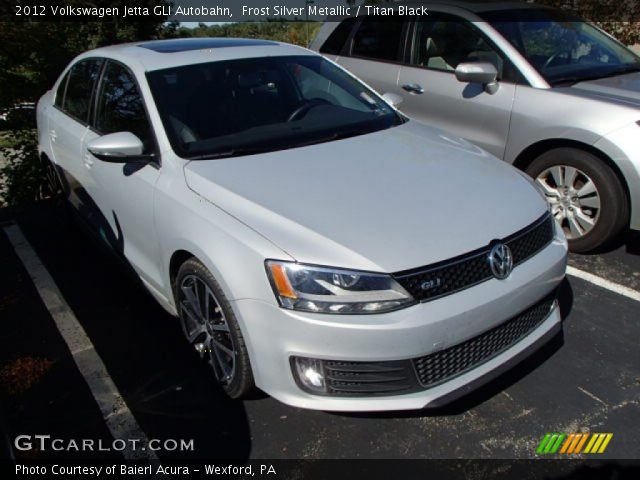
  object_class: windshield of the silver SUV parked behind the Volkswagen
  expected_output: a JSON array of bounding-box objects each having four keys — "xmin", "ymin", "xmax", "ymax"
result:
[{"xmin": 481, "ymin": 9, "xmax": 640, "ymax": 85}]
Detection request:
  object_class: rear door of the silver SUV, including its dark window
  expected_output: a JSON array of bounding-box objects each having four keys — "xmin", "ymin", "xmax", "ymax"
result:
[{"xmin": 337, "ymin": 17, "xmax": 406, "ymax": 99}]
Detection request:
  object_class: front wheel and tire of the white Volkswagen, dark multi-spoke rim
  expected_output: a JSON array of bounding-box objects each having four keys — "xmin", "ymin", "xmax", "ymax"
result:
[{"xmin": 173, "ymin": 257, "xmax": 254, "ymax": 398}]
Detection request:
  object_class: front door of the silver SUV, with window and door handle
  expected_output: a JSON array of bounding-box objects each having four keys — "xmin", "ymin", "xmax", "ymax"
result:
[{"xmin": 398, "ymin": 13, "xmax": 518, "ymax": 158}]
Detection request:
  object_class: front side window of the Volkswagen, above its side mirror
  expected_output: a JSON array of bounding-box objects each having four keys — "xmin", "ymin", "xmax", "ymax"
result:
[{"xmin": 96, "ymin": 62, "xmax": 151, "ymax": 151}]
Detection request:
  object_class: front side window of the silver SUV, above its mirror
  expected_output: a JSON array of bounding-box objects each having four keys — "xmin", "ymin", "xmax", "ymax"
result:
[{"xmin": 411, "ymin": 18, "xmax": 504, "ymax": 78}]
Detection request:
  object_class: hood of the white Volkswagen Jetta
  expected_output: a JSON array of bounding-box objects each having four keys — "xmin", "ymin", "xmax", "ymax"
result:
[{"xmin": 185, "ymin": 121, "xmax": 546, "ymax": 272}]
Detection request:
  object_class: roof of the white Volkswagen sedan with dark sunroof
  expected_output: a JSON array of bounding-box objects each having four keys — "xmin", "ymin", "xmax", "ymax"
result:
[{"xmin": 74, "ymin": 37, "xmax": 317, "ymax": 71}]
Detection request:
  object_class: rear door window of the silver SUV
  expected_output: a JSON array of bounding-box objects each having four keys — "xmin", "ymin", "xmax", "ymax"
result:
[{"xmin": 351, "ymin": 18, "xmax": 402, "ymax": 61}]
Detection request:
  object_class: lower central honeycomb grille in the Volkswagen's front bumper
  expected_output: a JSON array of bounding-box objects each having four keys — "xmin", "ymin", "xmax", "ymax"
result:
[{"xmin": 413, "ymin": 293, "xmax": 556, "ymax": 388}]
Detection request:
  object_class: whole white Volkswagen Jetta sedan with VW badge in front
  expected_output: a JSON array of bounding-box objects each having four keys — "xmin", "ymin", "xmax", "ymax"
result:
[{"xmin": 37, "ymin": 39, "xmax": 567, "ymax": 410}]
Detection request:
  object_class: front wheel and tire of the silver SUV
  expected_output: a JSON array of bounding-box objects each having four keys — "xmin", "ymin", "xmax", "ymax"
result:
[{"xmin": 526, "ymin": 148, "xmax": 629, "ymax": 253}]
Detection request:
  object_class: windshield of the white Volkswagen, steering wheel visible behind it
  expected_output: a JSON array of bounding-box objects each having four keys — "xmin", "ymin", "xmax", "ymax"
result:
[{"xmin": 147, "ymin": 55, "xmax": 403, "ymax": 159}]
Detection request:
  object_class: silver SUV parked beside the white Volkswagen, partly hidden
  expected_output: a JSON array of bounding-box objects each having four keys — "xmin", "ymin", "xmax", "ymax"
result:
[{"xmin": 311, "ymin": 3, "xmax": 640, "ymax": 252}]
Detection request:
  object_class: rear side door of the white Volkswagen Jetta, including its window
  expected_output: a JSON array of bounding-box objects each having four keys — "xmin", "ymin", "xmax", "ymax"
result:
[{"xmin": 48, "ymin": 58, "xmax": 103, "ymax": 210}]
